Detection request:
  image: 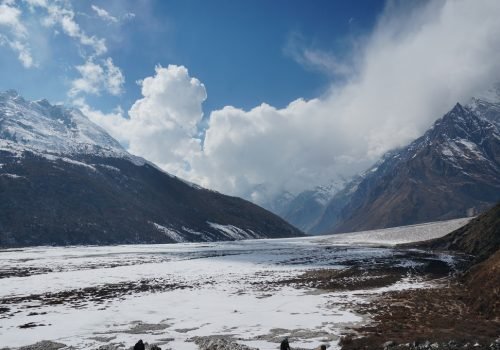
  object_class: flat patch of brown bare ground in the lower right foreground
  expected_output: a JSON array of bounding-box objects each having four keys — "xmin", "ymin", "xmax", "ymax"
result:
[{"xmin": 341, "ymin": 282, "xmax": 500, "ymax": 350}]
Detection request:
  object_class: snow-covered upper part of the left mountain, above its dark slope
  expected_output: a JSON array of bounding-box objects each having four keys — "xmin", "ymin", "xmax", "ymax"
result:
[{"xmin": 0, "ymin": 90, "xmax": 135, "ymax": 159}]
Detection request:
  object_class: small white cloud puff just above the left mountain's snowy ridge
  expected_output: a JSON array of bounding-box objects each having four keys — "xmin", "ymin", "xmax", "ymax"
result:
[{"xmin": 69, "ymin": 57, "xmax": 125, "ymax": 97}]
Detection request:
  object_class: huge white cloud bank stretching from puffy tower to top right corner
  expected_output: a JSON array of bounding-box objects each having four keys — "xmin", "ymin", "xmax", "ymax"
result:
[{"xmin": 88, "ymin": 0, "xmax": 500, "ymax": 203}]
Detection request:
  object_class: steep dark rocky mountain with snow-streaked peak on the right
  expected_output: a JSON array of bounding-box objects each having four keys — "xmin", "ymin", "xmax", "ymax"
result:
[{"xmin": 309, "ymin": 98, "xmax": 500, "ymax": 233}]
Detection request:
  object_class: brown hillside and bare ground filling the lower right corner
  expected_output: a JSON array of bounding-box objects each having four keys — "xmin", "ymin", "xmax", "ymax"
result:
[{"xmin": 341, "ymin": 203, "xmax": 500, "ymax": 350}]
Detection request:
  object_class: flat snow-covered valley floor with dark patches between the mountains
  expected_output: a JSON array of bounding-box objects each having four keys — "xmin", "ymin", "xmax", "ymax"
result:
[{"xmin": 0, "ymin": 219, "xmax": 468, "ymax": 349}]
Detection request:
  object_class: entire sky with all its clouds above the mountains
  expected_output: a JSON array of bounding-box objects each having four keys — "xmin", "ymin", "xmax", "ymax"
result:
[{"xmin": 0, "ymin": 0, "xmax": 500, "ymax": 204}]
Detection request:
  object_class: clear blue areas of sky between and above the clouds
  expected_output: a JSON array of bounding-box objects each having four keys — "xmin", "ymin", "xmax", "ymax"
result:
[{"xmin": 0, "ymin": 0, "xmax": 383, "ymax": 114}]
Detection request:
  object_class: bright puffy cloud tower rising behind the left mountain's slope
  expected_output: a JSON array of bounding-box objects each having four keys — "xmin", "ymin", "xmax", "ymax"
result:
[{"xmin": 82, "ymin": 65, "xmax": 207, "ymax": 174}]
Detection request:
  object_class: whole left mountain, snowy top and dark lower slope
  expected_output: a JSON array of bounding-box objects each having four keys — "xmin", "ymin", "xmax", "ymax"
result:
[{"xmin": 0, "ymin": 91, "xmax": 302, "ymax": 246}]
